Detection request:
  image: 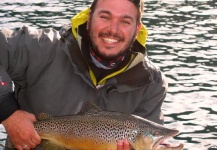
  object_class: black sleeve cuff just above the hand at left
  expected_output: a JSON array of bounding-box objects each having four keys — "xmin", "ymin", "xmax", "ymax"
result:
[{"xmin": 0, "ymin": 93, "xmax": 20, "ymax": 123}]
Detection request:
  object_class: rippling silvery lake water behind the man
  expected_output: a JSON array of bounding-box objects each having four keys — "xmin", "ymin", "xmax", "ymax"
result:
[{"xmin": 0, "ymin": 0, "xmax": 217, "ymax": 150}]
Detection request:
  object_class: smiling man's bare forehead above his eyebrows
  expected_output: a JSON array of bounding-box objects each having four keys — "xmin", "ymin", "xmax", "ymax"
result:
[{"xmin": 95, "ymin": 0, "xmax": 138, "ymax": 18}]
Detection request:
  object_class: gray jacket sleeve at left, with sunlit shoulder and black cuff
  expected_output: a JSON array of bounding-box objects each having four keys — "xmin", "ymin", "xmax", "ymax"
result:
[{"xmin": 0, "ymin": 26, "xmax": 62, "ymax": 122}]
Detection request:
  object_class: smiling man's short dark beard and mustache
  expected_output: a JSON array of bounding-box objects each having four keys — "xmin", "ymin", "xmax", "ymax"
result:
[{"xmin": 88, "ymin": 21, "xmax": 136, "ymax": 61}]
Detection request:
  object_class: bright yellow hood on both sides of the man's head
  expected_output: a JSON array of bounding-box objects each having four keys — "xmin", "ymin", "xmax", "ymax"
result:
[{"xmin": 71, "ymin": 8, "xmax": 148, "ymax": 48}]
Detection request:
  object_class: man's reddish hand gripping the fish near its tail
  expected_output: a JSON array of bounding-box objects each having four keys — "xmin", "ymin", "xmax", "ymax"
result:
[{"xmin": 2, "ymin": 110, "xmax": 41, "ymax": 150}]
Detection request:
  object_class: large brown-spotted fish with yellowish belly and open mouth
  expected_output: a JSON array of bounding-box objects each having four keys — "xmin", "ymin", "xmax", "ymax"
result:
[{"xmin": 8, "ymin": 102, "xmax": 183, "ymax": 150}]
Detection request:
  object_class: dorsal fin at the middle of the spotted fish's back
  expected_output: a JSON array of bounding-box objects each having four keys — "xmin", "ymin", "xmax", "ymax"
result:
[{"xmin": 79, "ymin": 101, "xmax": 102, "ymax": 114}]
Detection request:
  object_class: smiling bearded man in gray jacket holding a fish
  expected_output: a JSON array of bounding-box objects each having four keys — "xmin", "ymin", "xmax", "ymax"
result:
[{"xmin": 0, "ymin": 0, "xmax": 167, "ymax": 150}]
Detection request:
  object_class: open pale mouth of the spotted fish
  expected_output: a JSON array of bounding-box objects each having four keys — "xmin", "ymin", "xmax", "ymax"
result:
[{"xmin": 152, "ymin": 130, "xmax": 184, "ymax": 150}]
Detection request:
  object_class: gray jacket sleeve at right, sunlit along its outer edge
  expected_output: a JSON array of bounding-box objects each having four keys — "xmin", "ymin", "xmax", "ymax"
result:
[{"xmin": 134, "ymin": 61, "xmax": 168, "ymax": 124}]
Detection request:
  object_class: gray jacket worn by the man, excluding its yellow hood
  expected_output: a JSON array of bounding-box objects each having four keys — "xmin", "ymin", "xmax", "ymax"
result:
[{"xmin": 0, "ymin": 11, "xmax": 167, "ymax": 124}]
